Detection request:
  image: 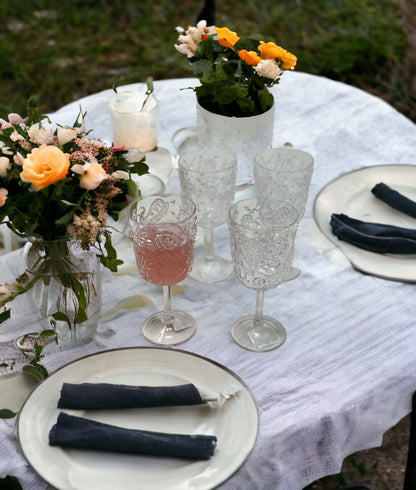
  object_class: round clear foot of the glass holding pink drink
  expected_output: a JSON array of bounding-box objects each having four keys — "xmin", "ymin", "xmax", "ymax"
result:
[{"xmin": 143, "ymin": 310, "xmax": 196, "ymax": 345}]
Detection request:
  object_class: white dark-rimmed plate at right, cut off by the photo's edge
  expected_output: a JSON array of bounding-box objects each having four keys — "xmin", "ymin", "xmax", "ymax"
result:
[{"xmin": 314, "ymin": 164, "xmax": 416, "ymax": 282}]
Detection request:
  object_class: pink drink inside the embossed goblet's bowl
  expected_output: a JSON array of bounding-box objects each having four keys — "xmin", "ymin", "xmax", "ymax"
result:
[{"xmin": 134, "ymin": 223, "xmax": 194, "ymax": 286}]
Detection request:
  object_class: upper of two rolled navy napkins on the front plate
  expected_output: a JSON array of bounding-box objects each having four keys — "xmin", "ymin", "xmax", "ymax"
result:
[{"xmin": 58, "ymin": 383, "xmax": 205, "ymax": 410}]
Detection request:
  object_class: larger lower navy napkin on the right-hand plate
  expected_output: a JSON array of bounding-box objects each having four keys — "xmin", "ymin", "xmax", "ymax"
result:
[{"xmin": 330, "ymin": 214, "xmax": 416, "ymax": 254}]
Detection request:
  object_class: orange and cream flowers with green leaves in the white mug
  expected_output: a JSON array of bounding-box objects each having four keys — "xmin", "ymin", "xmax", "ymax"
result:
[{"xmin": 175, "ymin": 21, "xmax": 297, "ymax": 117}]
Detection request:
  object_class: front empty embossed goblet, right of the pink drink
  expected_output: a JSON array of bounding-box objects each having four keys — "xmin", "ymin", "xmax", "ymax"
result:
[{"xmin": 228, "ymin": 198, "xmax": 297, "ymax": 352}]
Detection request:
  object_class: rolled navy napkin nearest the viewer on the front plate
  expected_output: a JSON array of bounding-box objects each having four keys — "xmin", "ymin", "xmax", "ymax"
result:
[{"xmin": 49, "ymin": 412, "xmax": 217, "ymax": 459}]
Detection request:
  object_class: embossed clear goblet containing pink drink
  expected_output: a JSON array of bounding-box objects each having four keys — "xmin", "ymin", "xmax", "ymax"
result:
[{"xmin": 129, "ymin": 195, "xmax": 196, "ymax": 345}]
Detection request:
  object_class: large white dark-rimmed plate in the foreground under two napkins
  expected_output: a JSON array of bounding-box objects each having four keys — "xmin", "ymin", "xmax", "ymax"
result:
[{"xmin": 17, "ymin": 347, "xmax": 258, "ymax": 490}]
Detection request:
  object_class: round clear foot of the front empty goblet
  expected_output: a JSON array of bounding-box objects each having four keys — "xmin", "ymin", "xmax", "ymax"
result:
[{"xmin": 231, "ymin": 315, "xmax": 286, "ymax": 352}]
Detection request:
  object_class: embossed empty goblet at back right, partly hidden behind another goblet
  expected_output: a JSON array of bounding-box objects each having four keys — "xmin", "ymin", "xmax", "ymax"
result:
[{"xmin": 254, "ymin": 146, "xmax": 314, "ymax": 281}]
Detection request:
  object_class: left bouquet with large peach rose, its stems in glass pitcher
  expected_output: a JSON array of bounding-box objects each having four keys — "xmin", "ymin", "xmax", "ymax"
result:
[{"xmin": 0, "ymin": 104, "xmax": 148, "ymax": 329}]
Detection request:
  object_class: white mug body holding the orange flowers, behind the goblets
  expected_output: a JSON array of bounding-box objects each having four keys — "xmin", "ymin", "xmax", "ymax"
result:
[{"xmin": 197, "ymin": 103, "xmax": 274, "ymax": 185}]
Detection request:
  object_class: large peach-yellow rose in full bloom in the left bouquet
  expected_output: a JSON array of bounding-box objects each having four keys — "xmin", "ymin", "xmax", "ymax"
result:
[{"xmin": 20, "ymin": 145, "xmax": 69, "ymax": 191}]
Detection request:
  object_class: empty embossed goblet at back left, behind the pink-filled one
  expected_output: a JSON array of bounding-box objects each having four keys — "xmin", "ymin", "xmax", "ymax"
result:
[{"xmin": 178, "ymin": 148, "xmax": 237, "ymax": 283}]
